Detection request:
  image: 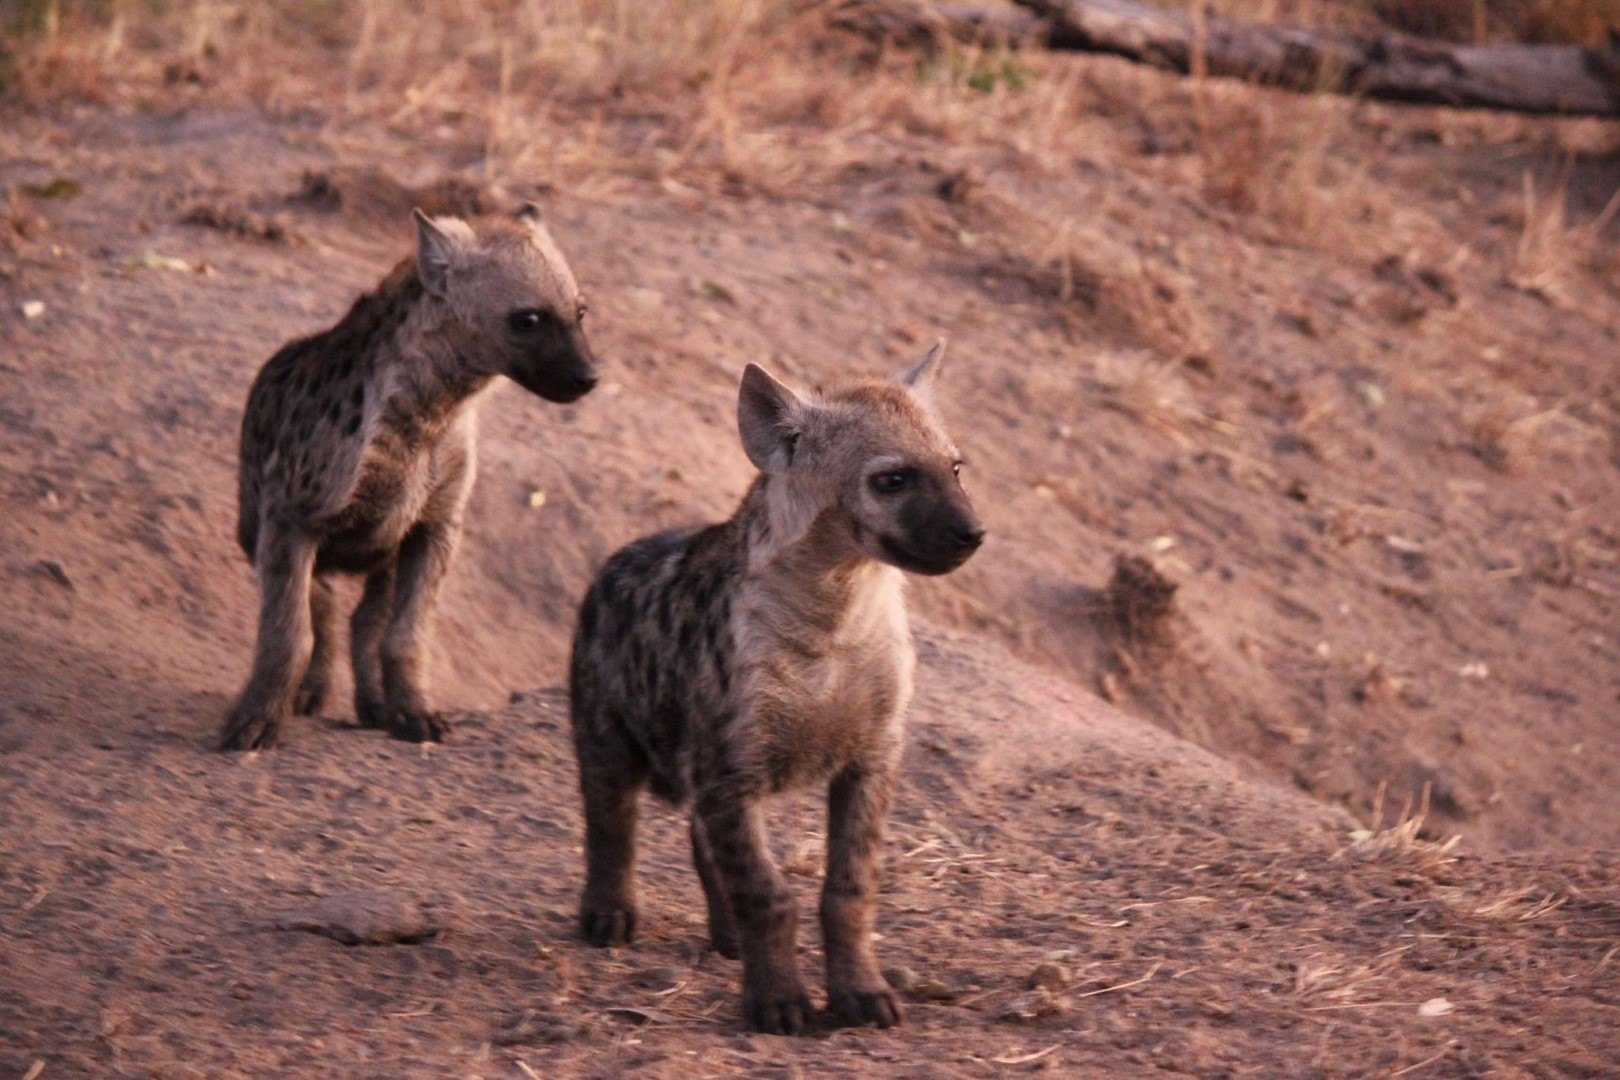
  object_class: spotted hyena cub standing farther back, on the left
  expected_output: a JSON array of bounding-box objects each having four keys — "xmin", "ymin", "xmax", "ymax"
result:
[{"xmin": 222, "ymin": 204, "xmax": 596, "ymax": 750}]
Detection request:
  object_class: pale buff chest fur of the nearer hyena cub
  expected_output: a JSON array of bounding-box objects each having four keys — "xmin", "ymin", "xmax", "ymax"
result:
[{"xmin": 735, "ymin": 565, "xmax": 915, "ymax": 790}]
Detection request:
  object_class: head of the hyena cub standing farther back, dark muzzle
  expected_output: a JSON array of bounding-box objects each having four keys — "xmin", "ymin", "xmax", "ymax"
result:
[{"xmin": 416, "ymin": 202, "xmax": 596, "ymax": 402}]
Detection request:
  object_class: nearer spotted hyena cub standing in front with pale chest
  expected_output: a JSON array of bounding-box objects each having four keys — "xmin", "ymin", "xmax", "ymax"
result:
[{"xmin": 570, "ymin": 342, "xmax": 985, "ymax": 1033}]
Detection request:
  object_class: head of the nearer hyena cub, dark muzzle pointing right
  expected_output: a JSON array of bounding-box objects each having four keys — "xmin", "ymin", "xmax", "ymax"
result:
[{"xmin": 737, "ymin": 342, "xmax": 985, "ymax": 573}]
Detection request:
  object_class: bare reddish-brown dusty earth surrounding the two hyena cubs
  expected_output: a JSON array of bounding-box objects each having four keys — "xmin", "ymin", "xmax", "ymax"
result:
[{"xmin": 0, "ymin": 21, "xmax": 1620, "ymax": 1080}]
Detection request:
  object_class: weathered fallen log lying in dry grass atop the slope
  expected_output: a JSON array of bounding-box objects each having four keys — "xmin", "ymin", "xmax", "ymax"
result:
[{"xmin": 839, "ymin": 0, "xmax": 1620, "ymax": 117}]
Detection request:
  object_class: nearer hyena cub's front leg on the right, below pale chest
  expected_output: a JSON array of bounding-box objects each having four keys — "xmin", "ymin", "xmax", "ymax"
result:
[{"xmin": 821, "ymin": 766, "xmax": 904, "ymax": 1028}]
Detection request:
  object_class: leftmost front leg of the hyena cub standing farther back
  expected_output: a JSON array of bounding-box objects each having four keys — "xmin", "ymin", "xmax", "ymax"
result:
[{"xmin": 220, "ymin": 521, "xmax": 316, "ymax": 750}]
